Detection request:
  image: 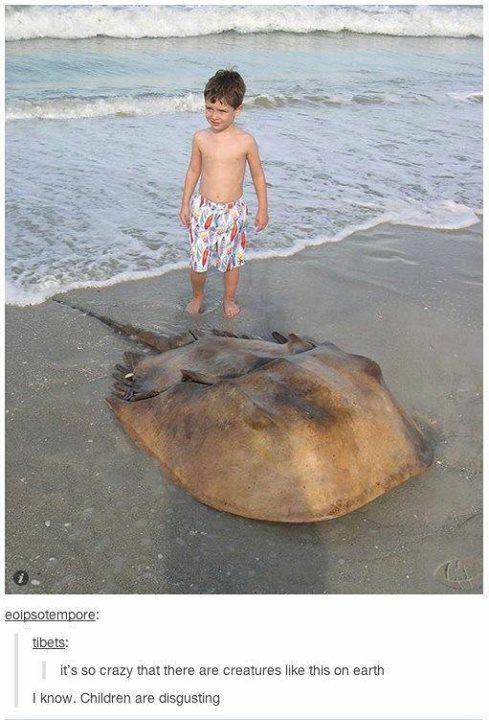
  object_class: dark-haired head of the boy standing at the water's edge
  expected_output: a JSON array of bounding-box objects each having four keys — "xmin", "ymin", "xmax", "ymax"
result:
[{"xmin": 204, "ymin": 70, "xmax": 246, "ymax": 132}]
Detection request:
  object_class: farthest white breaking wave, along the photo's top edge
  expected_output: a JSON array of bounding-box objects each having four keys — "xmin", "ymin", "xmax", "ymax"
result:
[{"xmin": 6, "ymin": 5, "xmax": 482, "ymax": 41}]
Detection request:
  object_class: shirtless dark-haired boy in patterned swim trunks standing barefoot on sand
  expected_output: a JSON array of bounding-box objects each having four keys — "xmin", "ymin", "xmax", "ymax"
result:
[{"xmin": 180, "ymin": 70, "xmax": 268, "ymax": 317}]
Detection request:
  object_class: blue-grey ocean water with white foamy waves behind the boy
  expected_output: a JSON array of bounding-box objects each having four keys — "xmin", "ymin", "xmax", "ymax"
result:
[{"xmin": 6, "ymin": 6, "xmax": 483, "ymax": 305}]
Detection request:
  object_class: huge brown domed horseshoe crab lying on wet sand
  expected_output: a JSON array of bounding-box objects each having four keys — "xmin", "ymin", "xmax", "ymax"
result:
[{"xmin": 95, "ymin": 318, "xmax": 432, "ymax": 522}]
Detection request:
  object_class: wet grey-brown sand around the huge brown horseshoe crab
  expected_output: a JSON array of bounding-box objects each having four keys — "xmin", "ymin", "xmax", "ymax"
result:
[{"xmin": 6, "ymin": 224, "xmax": 482, "ymax": 594}]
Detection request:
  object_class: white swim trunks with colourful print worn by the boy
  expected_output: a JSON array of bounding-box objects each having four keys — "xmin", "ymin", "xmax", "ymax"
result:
[{"xmin": 189, "ymin": 195, "xmax": 248, "ymax": 272}]
